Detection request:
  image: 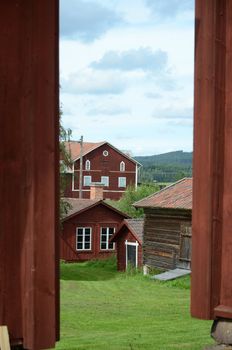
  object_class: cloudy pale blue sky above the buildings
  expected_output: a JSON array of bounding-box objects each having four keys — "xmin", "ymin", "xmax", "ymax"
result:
[{"xmin": 60, "ymin": 0, "xmax": 194, "ymax": 156}]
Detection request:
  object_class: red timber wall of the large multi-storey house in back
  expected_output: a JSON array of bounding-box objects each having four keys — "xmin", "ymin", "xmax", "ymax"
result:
[{"xmin": 65, "ymin": 144, "xmax": 136, "ymax": 200}]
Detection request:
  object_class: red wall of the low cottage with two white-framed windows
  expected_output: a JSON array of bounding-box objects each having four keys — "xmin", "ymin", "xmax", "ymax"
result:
[{"xmin": 60, "ymin": 204, "xmax": 124, "ymax": 261}]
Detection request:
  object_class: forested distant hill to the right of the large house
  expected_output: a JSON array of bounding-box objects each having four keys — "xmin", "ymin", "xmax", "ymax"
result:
[{"xmin": 134, "ymin": 151, "xmax": 193, "ymax": 182}]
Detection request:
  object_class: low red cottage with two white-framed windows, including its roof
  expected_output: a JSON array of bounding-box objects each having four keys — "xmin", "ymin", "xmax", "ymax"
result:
[{"xmin": 60, "ymin": 198, "xmax": 128, "ymax": 261}]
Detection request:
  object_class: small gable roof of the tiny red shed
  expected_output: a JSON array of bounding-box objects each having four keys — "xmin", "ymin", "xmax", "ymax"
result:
[{"xmin": 110, "ymin": 219, "xmax": 144, "ymax": 244}]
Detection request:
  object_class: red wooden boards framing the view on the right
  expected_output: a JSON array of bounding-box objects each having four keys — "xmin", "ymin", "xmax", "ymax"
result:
[{"xmin": 191, "ymin": 0, "xmax": 232, "ymax": 319}]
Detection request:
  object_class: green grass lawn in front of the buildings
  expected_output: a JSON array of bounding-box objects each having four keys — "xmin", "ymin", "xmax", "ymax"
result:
[{"xmin": 57, "ymin": 259, "xmax": 214, "ymax": 350}]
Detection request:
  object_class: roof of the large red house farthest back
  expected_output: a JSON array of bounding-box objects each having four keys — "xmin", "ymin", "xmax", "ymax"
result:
[{"xmin": 64, "ymin": 141, "xmax": 141, "ymax": 166}]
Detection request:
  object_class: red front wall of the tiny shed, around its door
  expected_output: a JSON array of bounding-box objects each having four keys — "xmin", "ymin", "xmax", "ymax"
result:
[{"xmin": 116, "ymin": 226, "xmax": 143, "ymax": 271}]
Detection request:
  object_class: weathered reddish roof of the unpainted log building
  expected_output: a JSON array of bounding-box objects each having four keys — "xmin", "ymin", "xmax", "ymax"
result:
[{"xmin": 133, "ymin": 178, "xmax": 192, "ymax": 210}]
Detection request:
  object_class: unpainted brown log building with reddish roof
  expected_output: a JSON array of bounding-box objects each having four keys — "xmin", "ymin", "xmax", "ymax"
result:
[{"xmin": 134, "ymin": 178, "xmax": 192, "ymax": 270}]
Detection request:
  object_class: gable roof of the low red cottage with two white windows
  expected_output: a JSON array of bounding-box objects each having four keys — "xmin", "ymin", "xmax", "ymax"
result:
[{"xmin": 63, "ymin": 198, "xmax": 129, "ymax": 221}]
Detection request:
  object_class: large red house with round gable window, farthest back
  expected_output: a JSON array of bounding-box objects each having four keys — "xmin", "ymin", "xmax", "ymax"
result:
[{"xmin": 61, "ymin": 141, "xmax": 140, "ymax": 200}]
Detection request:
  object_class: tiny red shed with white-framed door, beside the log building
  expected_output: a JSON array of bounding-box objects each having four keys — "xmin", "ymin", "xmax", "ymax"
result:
[{"xmin": 111, "ymin": 219, "xmax": 144, "ymax": 271}]
